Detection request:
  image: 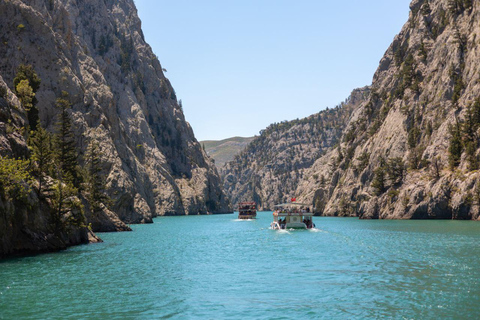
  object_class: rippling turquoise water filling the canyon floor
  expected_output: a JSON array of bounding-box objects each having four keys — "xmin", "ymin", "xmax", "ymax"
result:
[{"xmin": 0, "ymin": 212, "xmax": 480, "ymax": 319}]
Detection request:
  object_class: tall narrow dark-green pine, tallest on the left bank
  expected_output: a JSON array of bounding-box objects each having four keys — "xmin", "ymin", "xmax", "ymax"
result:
[{"xmin": 55, "ymin": 98, "xmax": 81, "ymax": 188}]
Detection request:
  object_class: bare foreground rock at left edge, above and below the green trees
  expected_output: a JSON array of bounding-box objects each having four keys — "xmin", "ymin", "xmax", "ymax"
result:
[{"xmin": 0, "ymin": 76, "xmax": 97, "ymax": 259}]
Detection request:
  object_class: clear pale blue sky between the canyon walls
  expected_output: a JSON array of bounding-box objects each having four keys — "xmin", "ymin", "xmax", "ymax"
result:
[{"xmin": 135, "ymin": 0, "xmax": 410, "ymax": 141}]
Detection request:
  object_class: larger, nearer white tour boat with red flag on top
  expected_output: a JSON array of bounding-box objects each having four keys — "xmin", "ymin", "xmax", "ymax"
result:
[{"xmin": 270, "ymin": 203, "xmax": 315, "ymax": 230}]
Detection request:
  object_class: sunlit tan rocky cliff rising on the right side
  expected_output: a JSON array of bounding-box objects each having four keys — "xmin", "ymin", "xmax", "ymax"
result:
[{"xmin": 296, "ymin": 0, "xmax": 480, "ymax": 219}]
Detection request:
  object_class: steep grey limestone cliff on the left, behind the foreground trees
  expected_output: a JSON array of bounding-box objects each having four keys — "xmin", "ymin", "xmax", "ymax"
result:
[{"xmin": 0, "ymin": 0, "xmax": 230, "ymax": 225}]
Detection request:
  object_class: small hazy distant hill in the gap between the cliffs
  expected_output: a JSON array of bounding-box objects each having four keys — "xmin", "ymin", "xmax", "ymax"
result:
[{"xmin": 200, "ymin": 137, "xmax": 254, "ymax": 168}]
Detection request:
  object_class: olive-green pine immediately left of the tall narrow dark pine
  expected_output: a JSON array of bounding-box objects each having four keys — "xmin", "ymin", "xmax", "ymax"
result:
[{"xmin": 28, "ymin": 124, "xmax": 53, "ymax": 196}]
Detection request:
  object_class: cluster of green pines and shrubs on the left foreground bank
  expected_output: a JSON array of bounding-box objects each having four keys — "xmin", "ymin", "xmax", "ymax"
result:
[{"xmin": 0, "ymin": 65, "xmax": 109, "ymax": 228}]
